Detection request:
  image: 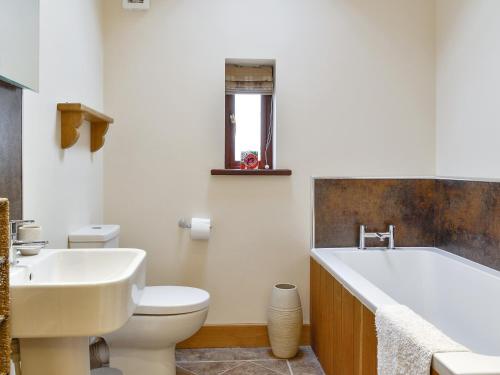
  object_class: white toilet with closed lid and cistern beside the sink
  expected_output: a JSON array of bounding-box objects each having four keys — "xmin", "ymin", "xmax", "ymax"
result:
[{"xmin": 69, "ymin": 225, "xmax": 210, "ymax": 375}]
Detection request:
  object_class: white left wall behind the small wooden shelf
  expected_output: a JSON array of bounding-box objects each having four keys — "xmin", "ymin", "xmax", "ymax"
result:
[{"xmin": 23, "ymin": 0, "xmax": 103, "ymax": 247}]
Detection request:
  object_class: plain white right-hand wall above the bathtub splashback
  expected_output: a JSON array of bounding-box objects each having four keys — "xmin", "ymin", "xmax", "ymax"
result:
[{"xmin": 436, "ymin": 0, "xmax": 500, "ymax": 178}]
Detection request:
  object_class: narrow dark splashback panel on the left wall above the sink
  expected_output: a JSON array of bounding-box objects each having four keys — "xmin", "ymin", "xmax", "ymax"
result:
[{"xmin": 0, "ymin": 81, "xmax": 23, "ymax": 219}]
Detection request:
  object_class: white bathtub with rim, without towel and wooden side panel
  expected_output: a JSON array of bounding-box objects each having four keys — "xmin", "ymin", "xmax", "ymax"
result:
[{"xmin": 311, "ymin": 248, "xmax": 500, "ymax": 375}]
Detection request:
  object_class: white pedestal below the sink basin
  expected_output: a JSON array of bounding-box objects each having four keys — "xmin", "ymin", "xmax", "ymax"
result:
[{"xmin": 19, "ymin": 337, "xmax": 90, "ymax": 375}]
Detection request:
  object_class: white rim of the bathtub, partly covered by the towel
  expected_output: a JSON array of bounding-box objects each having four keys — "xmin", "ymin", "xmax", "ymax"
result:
[{"xmin": 310, "ymin": 247, "xmax": 500, "ymax": 375}]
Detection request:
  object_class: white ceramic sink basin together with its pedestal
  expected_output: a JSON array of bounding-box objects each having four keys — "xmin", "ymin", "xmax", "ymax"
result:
[{"xmin": 10, "ymin": 249, "xmax": 146, "ymax": 375}]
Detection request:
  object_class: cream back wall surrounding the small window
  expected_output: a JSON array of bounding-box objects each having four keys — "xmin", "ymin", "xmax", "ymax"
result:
[{"xmin": 104, "ymin": 0, "xmax": 435, "ymax": 324}]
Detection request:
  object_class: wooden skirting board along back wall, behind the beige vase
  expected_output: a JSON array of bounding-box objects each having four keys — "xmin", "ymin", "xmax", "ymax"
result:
[{"xmin": 177, "ymin": 324, "xmax": 311, "ymax": 349}]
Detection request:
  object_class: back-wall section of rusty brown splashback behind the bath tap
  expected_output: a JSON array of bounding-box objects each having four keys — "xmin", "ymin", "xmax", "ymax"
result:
[{"xmin": 314, "ymin": 179, "xmax": 434, "ymax": 247}]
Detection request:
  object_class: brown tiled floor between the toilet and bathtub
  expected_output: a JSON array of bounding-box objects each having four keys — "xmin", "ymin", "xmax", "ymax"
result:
[{"xmin": 176, "ymin": 346, "xmax": 324, "ymax": 375}]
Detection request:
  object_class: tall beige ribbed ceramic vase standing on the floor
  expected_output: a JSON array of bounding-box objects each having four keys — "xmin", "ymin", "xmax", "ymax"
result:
[{"xmin": 267, "ymin": 284, "xmax": 303, "ymax": 358}]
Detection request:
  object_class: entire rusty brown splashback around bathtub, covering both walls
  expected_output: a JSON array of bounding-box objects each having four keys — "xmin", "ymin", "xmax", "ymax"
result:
[{"xmin": 314, "ymin": 179, "xmax": 500, "ymax": 270}]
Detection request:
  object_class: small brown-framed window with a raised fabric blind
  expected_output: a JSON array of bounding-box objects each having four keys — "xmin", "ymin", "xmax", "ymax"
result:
[{"xmin": 225, "ymin": 64, "xmax": 274, "ymax": 169}]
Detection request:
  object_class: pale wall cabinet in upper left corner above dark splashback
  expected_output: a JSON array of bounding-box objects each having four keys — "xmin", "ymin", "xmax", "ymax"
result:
[{"xmin": 0, "ymin": 0, "xmax": 40, "ymax": 91}]
